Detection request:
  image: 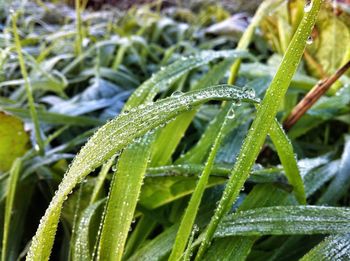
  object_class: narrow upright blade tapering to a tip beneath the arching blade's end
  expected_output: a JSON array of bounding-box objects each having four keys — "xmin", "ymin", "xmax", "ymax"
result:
[{"xmin": 169, "ymin": 104, "xmax": 234, "ymax": 261}]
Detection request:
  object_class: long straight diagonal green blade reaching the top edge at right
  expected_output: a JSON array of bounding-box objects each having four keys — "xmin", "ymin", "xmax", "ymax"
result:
[{"xmin": 196, "ymin": 0, "xmax": 321, "ymax": 260}]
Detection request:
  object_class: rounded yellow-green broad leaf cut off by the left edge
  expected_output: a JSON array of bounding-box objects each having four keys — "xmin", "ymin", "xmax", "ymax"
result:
[{"xmin": 0, "ymin": 111, "xmax": 29, "ymax": 172}]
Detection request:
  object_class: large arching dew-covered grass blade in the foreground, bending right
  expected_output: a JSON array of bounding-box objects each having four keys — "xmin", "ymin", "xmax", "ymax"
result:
[{"xmin": 27, "ymin": 85, "xmax": 253, "ymax": 260}]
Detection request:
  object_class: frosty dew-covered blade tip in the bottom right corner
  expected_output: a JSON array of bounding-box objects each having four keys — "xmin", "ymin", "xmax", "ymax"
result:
[{"xmin": 300, "ymin": 234, "xmax": 350, "ymax": 261}]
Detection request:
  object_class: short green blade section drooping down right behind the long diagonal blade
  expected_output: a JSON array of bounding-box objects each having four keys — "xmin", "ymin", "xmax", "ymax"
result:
[{"xmin": 269, "ymin": 120, "xmax": 306, "ymax": 205}]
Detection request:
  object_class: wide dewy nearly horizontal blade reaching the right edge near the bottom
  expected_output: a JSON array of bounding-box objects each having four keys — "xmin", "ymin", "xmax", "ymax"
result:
[{"xmin": 215, "ymin": 206, "xmax": 350, "ymax": 237}]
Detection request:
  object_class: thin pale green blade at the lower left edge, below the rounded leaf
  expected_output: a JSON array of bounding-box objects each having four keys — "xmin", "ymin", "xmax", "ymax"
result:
[{"xmin": 1, "ymin": 158, "xmax": 22, "ymax": 261}]
